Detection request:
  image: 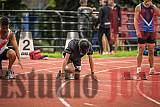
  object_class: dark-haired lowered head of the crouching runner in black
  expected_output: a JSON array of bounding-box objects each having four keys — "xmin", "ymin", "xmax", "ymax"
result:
[{"xmin": 79, "ymin": 39, "xmax": 90, "ymax": 54}]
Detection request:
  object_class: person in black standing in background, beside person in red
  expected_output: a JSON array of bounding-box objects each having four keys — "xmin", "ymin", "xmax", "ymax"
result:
[{"xmin": 99, "ymin": 0, "xmax": 113, "ymax": 54}]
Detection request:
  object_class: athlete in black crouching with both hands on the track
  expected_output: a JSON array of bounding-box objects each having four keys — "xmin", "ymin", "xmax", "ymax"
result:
[{"xmin": 57, "ymin": 39, "xmax": 96, "ymax": 80}]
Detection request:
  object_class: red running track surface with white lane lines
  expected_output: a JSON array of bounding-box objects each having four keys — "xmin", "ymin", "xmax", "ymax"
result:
[{"xmin": 0, "ymin": 57, "xmax": 160, "ymax": 107}]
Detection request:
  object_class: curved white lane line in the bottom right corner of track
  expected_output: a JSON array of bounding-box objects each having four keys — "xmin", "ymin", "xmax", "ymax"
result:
[{"xmin": 136, "ymin": 81, "xmax": 160, "ymax": 105}]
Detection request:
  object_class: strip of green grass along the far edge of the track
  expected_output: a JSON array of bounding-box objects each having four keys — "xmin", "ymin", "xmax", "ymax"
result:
[{"xmin": 43, "ymin": 50, "xmax": 137, "ymax": 58}]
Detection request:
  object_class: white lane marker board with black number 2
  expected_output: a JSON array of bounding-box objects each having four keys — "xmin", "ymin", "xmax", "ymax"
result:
[{"xmin": 19, "ymin": 32, "xmax": 34, "ymax": 58}]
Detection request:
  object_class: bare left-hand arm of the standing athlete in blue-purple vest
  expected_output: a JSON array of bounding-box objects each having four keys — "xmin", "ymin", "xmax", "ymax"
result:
[{"xmin": 134, "ymin": 5, "xmax": 141, "ymax": 37}]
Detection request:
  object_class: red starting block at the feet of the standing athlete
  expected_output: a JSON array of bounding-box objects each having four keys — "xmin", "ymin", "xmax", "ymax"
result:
[{"xmin": 123, "ymin": 72, "xmax": 147, "ymax": 80}]
